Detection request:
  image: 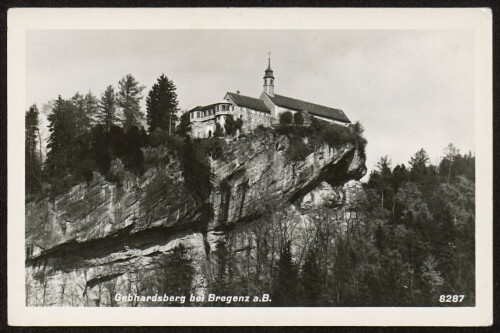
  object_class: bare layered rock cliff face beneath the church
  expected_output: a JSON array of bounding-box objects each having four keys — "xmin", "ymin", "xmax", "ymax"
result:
[{"xmin": 26, "ymin": 131, "xmax": 366, "ymax": 306}]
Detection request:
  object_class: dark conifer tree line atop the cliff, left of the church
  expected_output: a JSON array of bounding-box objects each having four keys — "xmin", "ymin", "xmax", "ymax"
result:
[{"xmin": 25, "ymin": 74, "xmax": 182, "ymax": 198}]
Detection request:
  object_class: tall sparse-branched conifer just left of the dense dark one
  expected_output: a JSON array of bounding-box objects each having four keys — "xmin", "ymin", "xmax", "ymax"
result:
[{"xmin": 117, "ymin": 74, "xmax": 146, "ymax": 131}]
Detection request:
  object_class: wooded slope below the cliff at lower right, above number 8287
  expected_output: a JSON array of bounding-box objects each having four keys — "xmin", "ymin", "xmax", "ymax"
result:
[{"xmin": 197, "ymin": 144, "xmax": 475, "ymax": 306}]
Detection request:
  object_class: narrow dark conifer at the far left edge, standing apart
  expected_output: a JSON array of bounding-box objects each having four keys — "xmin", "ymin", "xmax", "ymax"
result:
[{"xmin": 24, "ymin": 104, "xmax": 41, "ymax": 193}]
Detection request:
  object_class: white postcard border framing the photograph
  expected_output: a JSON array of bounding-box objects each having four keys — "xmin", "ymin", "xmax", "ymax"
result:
[{"xmin": 7, "ymin": 8, "xmax": 493, "ymax": 326}]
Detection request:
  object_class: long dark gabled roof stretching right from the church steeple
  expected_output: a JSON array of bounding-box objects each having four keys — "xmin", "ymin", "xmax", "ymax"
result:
[{"xmin": 267, "ymin": 94, "xmax": 351, "ymax": 123}]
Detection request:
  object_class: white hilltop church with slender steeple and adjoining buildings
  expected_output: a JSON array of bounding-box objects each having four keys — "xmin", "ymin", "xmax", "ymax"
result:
[{"xmin": 188, "ymin": 57, "xmax": 351, "ymax": 138}]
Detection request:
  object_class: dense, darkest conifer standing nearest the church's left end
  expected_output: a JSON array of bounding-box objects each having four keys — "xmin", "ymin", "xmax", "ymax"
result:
[{"xmin": 146, "ymin": 74, "xmax": 179, "ymax": 135}]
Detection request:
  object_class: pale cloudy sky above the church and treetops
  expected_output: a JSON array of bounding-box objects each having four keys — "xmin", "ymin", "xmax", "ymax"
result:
[{"xmin": 26, "ymin": 30, "xmax": 475, "ymax": 176}]
